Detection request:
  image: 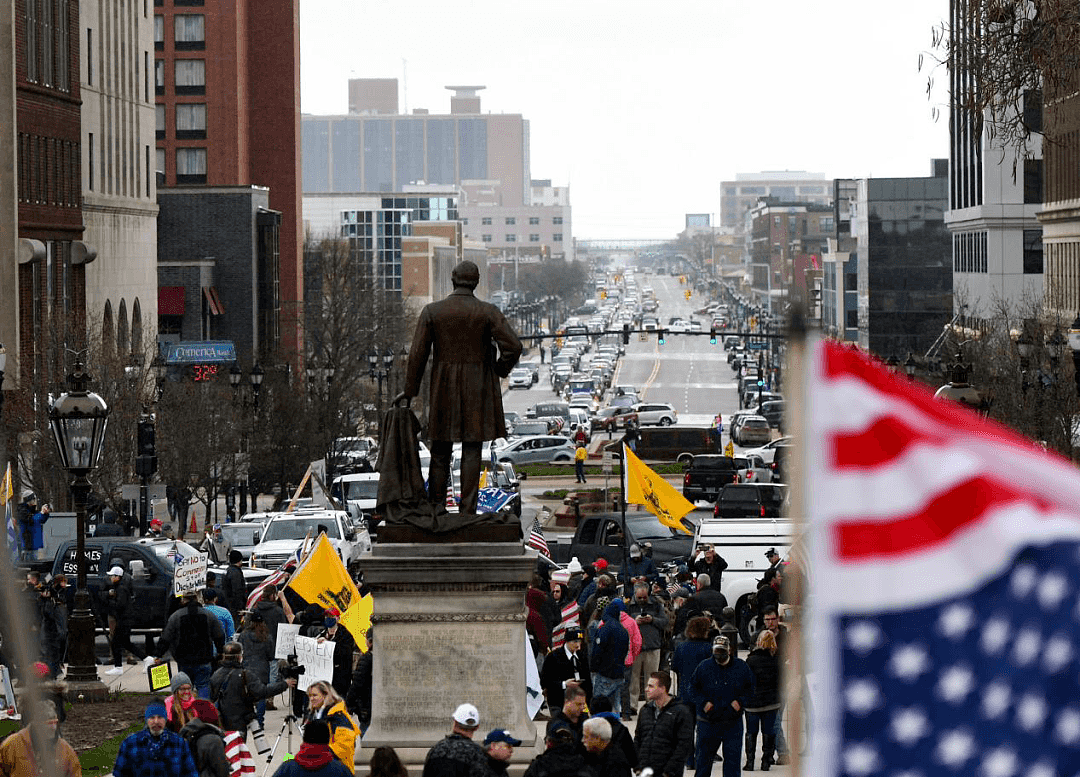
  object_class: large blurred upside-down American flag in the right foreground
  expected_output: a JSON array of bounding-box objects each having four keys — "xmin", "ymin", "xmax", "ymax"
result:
[{"xmin": 802, "ymin": 344, "xmax": 1080, "ymax": 777}]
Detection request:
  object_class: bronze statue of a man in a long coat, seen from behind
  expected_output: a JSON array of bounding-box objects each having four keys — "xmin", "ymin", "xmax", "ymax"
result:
[{"xmin": 395, "ymin": 260, "xmax": 522, "ymax": 514}]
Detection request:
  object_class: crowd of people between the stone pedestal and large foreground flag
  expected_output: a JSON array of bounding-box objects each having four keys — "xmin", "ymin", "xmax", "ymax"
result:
[{"xmin": 526, "ymin": 546, "xmax": 789, "ymax": 777}]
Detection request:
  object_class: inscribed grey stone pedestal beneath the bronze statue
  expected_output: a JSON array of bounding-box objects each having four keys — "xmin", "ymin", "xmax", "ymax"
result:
[{"xmin": 356, "ymin": 538, "xmax": 542, "ymax": 774}]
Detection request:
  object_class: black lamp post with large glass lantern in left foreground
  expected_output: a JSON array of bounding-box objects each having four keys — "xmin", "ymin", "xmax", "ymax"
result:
[{"xmin": 49, "ymin": 362, "xmax": 109, "ymax": 701}]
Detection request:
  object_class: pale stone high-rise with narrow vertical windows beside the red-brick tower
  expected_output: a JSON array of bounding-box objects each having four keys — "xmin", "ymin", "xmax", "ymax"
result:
[{"xmin": 77, "ymin": 0, "xmax": 158, "ymax": 360}]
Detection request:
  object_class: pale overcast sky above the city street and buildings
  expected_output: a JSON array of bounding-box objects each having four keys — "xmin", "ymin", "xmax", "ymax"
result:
[{"xmin": 300, "ymin": 0, "xmax": 948, "ymax": 239}]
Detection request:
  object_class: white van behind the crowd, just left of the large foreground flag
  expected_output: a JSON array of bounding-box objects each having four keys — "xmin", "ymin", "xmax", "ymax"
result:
[{"xmin": 690, "ymin": 518, "xmax": 795, "ymax": 642}]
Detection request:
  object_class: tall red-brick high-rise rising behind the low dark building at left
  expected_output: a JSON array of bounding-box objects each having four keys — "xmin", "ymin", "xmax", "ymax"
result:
[{"xmin": 153, "ymin": 0, "xmax": 303, "ymax": 360}]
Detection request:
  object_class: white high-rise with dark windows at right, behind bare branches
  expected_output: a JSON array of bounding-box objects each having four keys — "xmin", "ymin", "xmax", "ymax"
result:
[{"xmin": 945, "ymin": 0, "xmax": 1043, "ymax": 322}]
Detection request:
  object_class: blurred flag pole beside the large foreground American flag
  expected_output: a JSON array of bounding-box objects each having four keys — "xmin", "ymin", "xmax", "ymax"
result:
[{"xmin": 782, "ymin": 303, "xmax": 810, "ymax": 777}]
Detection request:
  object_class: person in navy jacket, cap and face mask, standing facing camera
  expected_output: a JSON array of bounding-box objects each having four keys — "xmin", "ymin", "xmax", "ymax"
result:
[{"xmin": 690, "ymin": 637, "xmax": 754, "ymax": 777}]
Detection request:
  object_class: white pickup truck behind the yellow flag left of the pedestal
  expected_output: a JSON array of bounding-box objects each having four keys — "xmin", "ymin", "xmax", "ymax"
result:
[{"xmin": 252, "ymin": 509, "xmax": 372, "ymax": 571}]
